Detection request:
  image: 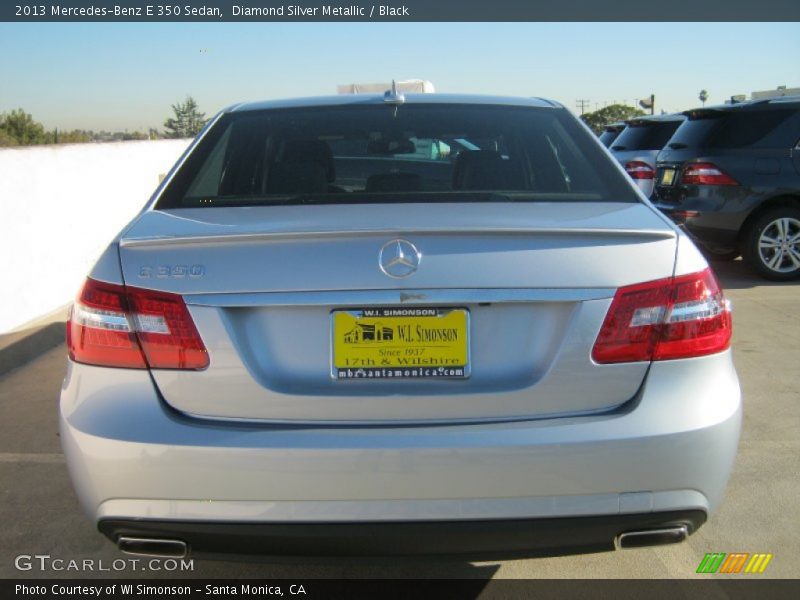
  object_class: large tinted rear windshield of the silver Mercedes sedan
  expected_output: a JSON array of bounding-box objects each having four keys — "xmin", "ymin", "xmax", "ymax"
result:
[{"xmin": 157, "ymin": 104, "xmax": 637, "ymax": 208}]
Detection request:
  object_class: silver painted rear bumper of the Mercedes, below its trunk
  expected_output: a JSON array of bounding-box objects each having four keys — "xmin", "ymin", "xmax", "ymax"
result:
[{"xmin": 60, "ymin": 352, "xmax": 741, "ymax": 552}]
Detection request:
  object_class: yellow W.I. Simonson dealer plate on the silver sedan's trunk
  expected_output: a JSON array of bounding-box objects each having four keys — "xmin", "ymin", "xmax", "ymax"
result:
[{"xmin": 331, "ymin": 308, "xmax": 469, "ymax": 380}]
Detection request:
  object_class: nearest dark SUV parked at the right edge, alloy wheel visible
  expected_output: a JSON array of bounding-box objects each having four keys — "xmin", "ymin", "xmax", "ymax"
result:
[{"xmin": 652, "ymin": 96, "xmax": 800, "ymax": 280}]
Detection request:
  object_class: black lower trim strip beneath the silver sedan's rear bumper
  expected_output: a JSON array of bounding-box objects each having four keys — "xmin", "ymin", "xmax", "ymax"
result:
[{"xmin": 98, "ymin": 510, "xmax": 706, "ymax": 560}]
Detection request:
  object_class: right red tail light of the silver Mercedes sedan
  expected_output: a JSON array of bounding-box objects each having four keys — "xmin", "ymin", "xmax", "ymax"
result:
[{"xmin": 592, "ymin": 268, "xmax": 732, "ymax": 364}]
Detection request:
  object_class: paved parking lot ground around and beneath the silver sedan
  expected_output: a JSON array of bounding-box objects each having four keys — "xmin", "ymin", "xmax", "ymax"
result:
[{"xmin": 0, "ymin": 261, "xmax": 800, "ymax": 579}]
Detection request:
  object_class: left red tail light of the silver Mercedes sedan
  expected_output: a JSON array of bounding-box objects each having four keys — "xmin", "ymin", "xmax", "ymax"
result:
[{"xmin": 67, "ymin": 279, "xmax": 208, "ymax": 369}]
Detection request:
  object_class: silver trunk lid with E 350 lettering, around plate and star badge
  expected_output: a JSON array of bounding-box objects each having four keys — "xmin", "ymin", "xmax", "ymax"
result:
[{"xmin": 120, "ymin": 202, "xmax": 676, "ymax": 423}]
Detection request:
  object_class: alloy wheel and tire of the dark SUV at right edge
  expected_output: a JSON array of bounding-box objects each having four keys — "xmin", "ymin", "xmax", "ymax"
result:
[{"xmin": 742, "ymin": 207, "xmax": 800, "ymax": 281}]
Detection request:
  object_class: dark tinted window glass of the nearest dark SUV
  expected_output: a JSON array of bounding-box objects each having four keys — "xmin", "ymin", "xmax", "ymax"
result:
[{"xmin": 669, "ymin": 109, "xmax": 795, "ymax": 149}]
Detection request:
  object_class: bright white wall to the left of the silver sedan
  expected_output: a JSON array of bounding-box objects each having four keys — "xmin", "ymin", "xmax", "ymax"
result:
[{"xmin": 0, "ymin": 140, "xmax": 189, "ymax": 334}]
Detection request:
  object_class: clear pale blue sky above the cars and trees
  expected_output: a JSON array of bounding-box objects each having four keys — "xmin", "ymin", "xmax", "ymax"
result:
[{"xmin": 0, "ymin": 23, "xmax": 800, "ymax": 130}]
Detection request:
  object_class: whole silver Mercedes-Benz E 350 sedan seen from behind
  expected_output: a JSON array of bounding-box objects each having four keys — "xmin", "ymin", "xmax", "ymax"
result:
[{"xmin": 60, "ymin": 93, "xmax": 741, "ymax": 558}]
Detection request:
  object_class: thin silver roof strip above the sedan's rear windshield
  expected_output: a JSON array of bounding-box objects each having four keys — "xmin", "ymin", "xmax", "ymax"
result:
[{"xmin": 223, "ymin": 93, "xmax": 563, "ymax": 112}]
